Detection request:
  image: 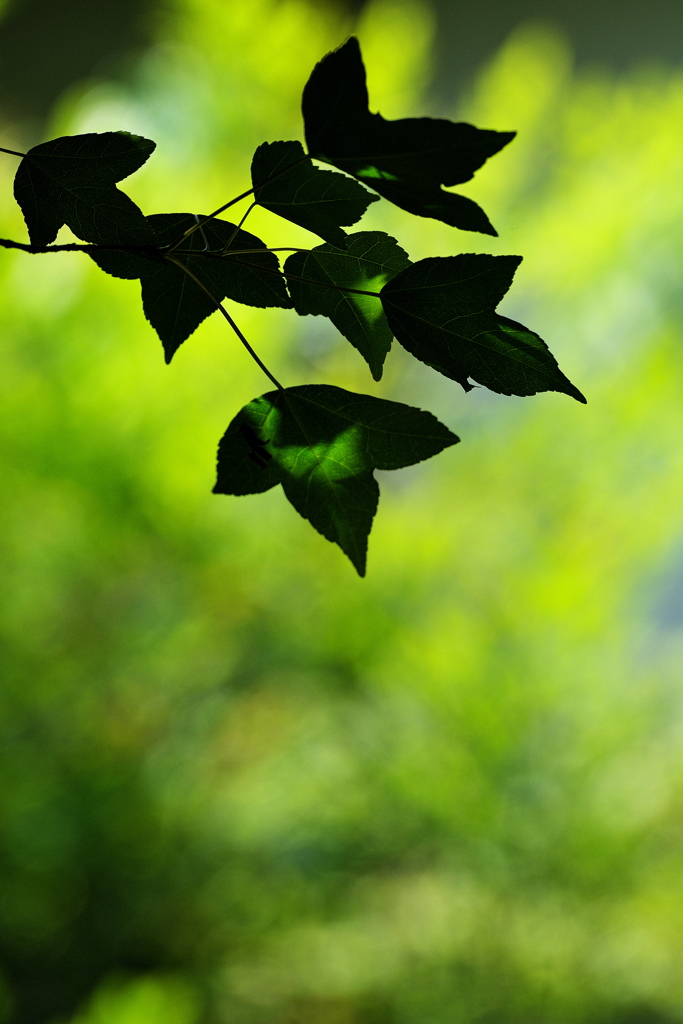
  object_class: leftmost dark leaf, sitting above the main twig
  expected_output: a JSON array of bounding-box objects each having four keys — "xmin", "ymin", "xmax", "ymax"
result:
[{"xmin": 14, "ymin": 131, "xmax": 155, "ymax": 246}]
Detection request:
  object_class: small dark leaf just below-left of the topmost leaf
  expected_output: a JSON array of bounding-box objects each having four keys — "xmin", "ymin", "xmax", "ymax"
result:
[{"xmin": 251, "ymin": 142, "xmax": 377, "ymax": 248}]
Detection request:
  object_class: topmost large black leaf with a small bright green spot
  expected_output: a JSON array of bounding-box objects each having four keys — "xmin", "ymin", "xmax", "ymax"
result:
[{"xmin": 302, "ymin": 37, "xmax": 516, "ymax": 234}]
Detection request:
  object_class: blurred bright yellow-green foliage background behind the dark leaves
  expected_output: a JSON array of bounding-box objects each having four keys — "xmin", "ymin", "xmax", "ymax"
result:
[{"xmin": 0, "ymin": 0, "xmax": 683, "ymax": 1024}]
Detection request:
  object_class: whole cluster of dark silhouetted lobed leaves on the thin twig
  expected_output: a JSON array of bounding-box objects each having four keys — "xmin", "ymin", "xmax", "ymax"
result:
[{"xmin": 0, "ymin": 38, "xmax": 585, "ymax": 575}]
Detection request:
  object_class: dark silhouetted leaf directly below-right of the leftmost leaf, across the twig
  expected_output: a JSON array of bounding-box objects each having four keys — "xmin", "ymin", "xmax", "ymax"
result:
[{"xmin": 90, "ymin": 213, "xmax": 292, "ymax": 362}]
